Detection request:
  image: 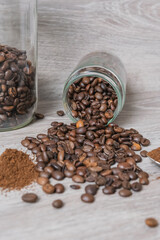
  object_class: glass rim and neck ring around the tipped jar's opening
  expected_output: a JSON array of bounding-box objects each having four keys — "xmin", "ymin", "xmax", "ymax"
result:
[{"xmin": 63, "ymin": 65, "xmax": 125, "ymax": 126}]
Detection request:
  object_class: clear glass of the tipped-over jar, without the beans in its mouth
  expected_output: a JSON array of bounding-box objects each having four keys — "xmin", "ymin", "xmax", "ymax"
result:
[{"xmin": 63, "ymin": 52, "xmax": 127, "ymax": 124}]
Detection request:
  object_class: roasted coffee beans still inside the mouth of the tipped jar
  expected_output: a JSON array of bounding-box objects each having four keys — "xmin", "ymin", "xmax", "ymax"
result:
[{"xmin": 68, "ymin": 77, "xmax": 118, "ymax": 125}]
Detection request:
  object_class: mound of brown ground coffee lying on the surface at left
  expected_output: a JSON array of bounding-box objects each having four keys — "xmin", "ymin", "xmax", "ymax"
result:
[{"xmin": 0, "ymin": 149, "xmax": 37, "ymax": 191}]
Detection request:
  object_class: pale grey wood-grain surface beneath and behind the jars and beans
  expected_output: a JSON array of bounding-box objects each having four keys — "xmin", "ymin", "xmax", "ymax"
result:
[{"xmin": 0, "ymin": 0, "xmax": 160, "ymax": 240}]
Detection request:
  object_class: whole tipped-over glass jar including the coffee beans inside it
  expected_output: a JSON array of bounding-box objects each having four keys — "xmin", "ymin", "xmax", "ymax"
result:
[{"xmin": 63, "ymin": 52, "xmax": 127, "ymax": 126}]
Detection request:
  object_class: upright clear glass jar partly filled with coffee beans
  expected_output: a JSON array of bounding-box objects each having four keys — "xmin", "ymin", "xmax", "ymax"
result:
[{"xmin": 0, "ymin": 0, "xmax": 37, "ymax": 131}]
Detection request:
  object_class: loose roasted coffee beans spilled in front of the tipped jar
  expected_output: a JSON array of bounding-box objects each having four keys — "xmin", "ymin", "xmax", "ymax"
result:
[{"xmin": 21, "ymin": 119, "xmax": 150, "ymax": 203}]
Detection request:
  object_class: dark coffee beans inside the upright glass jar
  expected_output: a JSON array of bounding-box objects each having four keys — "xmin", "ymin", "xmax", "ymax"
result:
[{"xmin": 0, "ymin": 45, "xmax": 36, "ymax": 128}]
